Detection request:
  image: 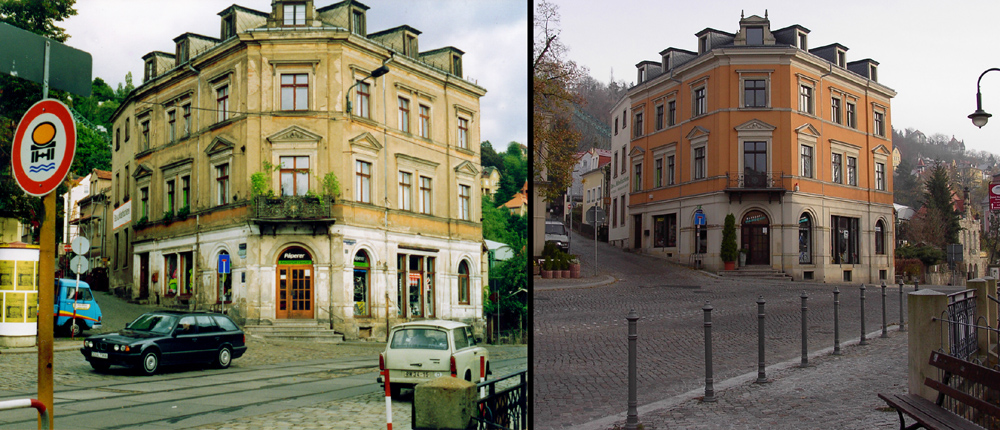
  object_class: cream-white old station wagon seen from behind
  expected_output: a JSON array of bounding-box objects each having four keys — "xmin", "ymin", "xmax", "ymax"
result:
[{"xmin": 378, "ymin": 320, "xmax": 490, "ymax": 397}]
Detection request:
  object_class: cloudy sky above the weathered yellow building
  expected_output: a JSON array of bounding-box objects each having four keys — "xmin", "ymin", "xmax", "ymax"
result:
[{"xmin": 58, "ymin": 0, "xmax": 528, "ymax": 151}]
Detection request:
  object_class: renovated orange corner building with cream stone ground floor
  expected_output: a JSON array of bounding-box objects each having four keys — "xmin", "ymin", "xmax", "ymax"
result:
[{"xmin": 622, "ymin": 14, "xmax": 896, "ymax": 282}]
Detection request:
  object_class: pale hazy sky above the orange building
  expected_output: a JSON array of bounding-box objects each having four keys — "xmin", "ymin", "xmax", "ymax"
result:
[{"xmin": 548, "ymin": 0, "xmax": 1000, "ymax": 154}]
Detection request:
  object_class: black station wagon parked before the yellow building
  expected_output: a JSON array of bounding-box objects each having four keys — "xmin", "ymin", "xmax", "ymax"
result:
[{"xmin": 80, "ymin": 311, "xmax": 247, "ymax": 375}]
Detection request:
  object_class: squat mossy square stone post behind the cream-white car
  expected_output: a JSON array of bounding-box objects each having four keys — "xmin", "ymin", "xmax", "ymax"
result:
[{"xmin": 413, "ymin": 376, "xmax": 476, "ymax": 430}]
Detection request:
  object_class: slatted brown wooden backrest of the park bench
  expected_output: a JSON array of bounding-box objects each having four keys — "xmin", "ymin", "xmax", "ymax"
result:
[{"xmin": 924, "ymin": 351, "xmax": 1000, "ymax": 421}]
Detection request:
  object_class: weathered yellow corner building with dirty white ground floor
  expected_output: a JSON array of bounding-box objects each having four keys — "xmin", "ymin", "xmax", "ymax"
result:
[{"xmin": 107, "ymin": 0, "xmax": 486, "ymax": 338}]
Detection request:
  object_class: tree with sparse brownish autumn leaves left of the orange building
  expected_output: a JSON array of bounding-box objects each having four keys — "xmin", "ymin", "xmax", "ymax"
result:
[{"xmin": 532, "ymin": 0, "xmax": 584, "ymax": 202}]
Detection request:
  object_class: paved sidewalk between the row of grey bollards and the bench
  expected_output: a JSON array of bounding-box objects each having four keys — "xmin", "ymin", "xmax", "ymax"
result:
[{"xmin": 576, "ymin": 327, "xmax": 909, "ymax": 430}]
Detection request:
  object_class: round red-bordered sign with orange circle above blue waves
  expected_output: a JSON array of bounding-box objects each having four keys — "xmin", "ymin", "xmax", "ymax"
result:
[{"xmin": 11, "ymin": 99, "xmax": 76, "ymax": 196}]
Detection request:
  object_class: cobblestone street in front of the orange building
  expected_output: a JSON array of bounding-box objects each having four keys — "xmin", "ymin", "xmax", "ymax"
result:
[{"xmin": 532, "ymin": 230, "xmax": 928, "ymax": 429}]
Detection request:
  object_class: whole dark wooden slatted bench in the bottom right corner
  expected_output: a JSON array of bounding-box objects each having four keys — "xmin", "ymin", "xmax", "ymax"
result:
[{"xmin": 878, "ymin": 351, "xmax": 1000, "ymax": 430}]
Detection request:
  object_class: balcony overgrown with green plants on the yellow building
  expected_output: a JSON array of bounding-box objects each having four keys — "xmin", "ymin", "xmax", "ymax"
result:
[{"xmin": 251, "ymin": 196, "xmax": 336, "ymax": 234}]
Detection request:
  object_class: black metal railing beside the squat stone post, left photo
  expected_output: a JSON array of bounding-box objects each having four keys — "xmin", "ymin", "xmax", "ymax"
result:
[{"xmin": 473, "ymin": 370, "xmax": 528, "ymax": 430}]
